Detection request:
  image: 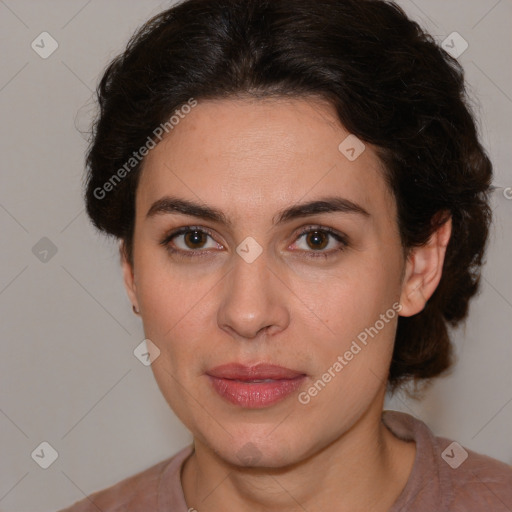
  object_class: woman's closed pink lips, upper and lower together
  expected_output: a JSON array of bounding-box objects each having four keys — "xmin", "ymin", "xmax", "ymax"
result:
[{"xmin": 206, "ymin": 363, "xmax": 306, "ymax": 409}]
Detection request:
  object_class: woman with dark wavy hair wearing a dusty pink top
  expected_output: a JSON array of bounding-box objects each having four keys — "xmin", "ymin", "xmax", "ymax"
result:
[{"xmin": 59, "ymin": 0, "xmax": 512, "ymax": 512}]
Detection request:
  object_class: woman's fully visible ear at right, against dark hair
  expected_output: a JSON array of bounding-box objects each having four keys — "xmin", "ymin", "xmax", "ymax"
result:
[{"xmin": 400, "ymin": 216, "xmax": 452, "ymax": 316}]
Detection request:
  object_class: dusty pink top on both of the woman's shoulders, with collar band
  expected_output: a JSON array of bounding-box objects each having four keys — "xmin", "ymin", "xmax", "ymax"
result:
[{"xmin": 59, "ymin": 411, "xmax": 512, "ymax": 512}]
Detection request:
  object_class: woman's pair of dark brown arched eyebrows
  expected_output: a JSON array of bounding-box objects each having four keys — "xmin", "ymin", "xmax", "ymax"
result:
[{"xmin": 146, "ymin": 196, "xmax": 371, "ymax": 226}]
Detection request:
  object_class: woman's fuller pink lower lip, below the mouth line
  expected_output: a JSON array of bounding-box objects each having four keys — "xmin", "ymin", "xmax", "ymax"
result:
[{"xmin": 208, "ymin": 375, "xmax": 306, "ymax": 409}]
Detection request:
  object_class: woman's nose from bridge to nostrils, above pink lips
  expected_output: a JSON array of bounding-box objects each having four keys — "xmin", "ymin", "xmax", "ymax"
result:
[{"xmin": 217, "ymin": 248, "xmax": 290, "ymax": 340}]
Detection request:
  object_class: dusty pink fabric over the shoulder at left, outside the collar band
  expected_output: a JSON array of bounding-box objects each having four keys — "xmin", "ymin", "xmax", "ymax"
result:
[{"xmin": 58, "ymin": 446, "xmax": 191, "ymax": 512}]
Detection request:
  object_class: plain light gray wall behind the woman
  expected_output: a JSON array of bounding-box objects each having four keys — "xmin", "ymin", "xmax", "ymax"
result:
[{"xmin": 0, "ymin": 0, "xmax": 512, "ymax": 512}]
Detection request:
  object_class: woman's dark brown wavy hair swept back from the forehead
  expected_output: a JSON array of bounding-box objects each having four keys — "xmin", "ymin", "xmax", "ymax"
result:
[{"xmin": 86, "ymin": 0, "xmax": 492, "ymax": 390}]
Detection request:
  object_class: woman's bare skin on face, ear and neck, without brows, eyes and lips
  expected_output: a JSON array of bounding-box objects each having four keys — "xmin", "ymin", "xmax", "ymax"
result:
[{"xmin": 121, "ymin": 98, "xmax": 451, "ymax": 512}]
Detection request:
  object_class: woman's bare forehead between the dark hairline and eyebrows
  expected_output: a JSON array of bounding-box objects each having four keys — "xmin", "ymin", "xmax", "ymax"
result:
[{"xmin": 137, "ymin": 98, "xmax": 394, "ymax": 222}]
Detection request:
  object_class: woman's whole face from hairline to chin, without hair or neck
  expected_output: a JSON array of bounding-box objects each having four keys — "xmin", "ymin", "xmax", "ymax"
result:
[{"xmin": 124, "ymin": 99, "xmax": 405, "ymax": 467}]
